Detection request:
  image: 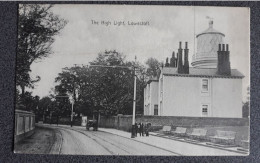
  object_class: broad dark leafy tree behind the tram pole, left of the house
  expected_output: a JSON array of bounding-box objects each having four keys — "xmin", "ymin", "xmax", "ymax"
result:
[{"xmin": 55, "ymin": 51, "xmax": 145, "ymax": 115}]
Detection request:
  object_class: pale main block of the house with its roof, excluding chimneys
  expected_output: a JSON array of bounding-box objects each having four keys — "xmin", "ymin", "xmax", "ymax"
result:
[{"xmin": 159, "ymin": 63, "xmax": 243, "ymax": 118}]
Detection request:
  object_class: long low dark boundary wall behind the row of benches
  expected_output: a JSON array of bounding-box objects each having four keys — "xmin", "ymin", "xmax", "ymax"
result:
[{"xmin": 99, "ymin": 115, "xmax": 249, "ymax": 131}]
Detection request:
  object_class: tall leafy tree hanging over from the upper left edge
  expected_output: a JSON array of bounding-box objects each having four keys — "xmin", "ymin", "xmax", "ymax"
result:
[{"xmin": 16, "ymin": 4, "xmax": 67, "ymax": 96}]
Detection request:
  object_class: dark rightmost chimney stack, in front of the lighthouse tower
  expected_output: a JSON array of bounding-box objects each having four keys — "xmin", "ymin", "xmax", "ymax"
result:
[{"xmin": 217, "ymin": 44, "xmax": 231, "ymax": 75}]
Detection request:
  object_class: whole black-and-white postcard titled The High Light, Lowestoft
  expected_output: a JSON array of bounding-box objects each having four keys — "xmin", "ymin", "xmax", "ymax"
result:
[{"xmin": 14, "ymin": 3, "xmax": 250, "ymax": 156}]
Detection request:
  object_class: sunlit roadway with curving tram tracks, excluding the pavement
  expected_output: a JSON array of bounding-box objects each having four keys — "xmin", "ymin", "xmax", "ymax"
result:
[{"xmin": 47, "ymin": 126, "xmax": 179, "ymax": 155}]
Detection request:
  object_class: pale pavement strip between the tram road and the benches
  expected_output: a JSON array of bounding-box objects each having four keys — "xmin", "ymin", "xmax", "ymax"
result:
[{"xmin": 59, "ymin": 126, "xmax": 248, "ymax": 156}]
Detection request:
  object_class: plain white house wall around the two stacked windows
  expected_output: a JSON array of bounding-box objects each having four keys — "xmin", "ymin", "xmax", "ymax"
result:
[{"xmin": 161, "ymin": 76, "xmax": 242, "ymax": 118}]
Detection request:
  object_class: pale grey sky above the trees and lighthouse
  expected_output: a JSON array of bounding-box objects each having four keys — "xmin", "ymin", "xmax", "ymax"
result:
[{"xmin": 28, "ymin": 4, "xmax": 250, "ymax": 101}]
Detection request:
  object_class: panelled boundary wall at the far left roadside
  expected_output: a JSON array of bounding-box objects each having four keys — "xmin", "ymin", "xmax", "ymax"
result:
[{"xmin": 14, "ymin": 110, "xmax": 35, "ymax": 143}]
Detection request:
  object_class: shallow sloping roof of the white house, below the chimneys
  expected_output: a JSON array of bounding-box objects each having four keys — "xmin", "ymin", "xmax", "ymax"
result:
[{"xmin": 162, "ymin": 67, "xmax": 244, "ymax": 78}]
